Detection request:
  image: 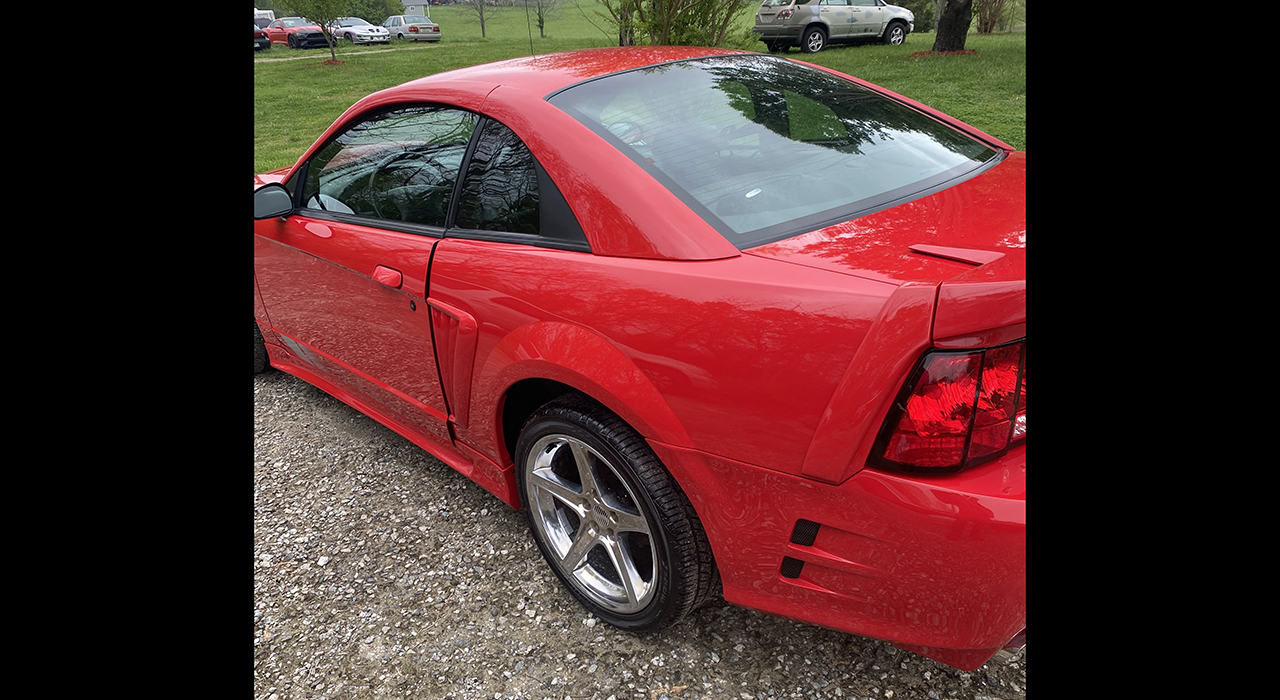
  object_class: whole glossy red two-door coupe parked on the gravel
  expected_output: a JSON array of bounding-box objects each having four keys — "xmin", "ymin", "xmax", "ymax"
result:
[{"xmin": 253, "ymin": 47, "xmax": 1027, "ymax": 669}]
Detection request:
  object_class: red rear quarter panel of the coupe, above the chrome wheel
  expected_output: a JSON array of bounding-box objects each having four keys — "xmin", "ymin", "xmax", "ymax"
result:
[{"xmin": 430, "ymin": 239, "xmax": 895, "ymax": 472}]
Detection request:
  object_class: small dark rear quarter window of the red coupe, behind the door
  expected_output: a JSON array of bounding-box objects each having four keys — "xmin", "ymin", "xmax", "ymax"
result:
[{"xmin": 457, "ymin": 120, "xmax": 539, "ymax": 235}]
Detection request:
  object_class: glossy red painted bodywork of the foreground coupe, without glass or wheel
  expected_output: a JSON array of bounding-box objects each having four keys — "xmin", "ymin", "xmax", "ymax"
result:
[{"xmin": 255, "ymin": 47, "xmax": 1027, "ymax": 668}]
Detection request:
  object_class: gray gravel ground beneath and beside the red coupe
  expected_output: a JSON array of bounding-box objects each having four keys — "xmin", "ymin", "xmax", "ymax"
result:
[{"xmin": 253, "ymin": 370, "xmax": 1027, "ymax": 700}]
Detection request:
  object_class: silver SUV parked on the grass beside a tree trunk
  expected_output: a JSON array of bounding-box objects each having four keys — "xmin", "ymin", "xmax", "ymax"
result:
[{"xmin": 751, "ymin": 0, "xmax": 915, "ymax": 54}]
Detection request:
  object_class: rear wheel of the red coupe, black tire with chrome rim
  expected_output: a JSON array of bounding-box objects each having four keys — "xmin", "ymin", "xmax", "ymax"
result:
[{"xmin": 516, "ymin": 394, "xmax": 719, "ymax": 631}]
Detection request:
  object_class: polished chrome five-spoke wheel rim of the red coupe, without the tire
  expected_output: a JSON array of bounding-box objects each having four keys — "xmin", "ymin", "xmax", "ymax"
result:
[{"xmin": 526, "ymin": 435, "xmax": 657, "ymax": 613}]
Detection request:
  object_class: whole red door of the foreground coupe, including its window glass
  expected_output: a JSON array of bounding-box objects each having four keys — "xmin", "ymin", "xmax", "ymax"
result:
[{"xmin": 255, "ymin": 105, "xmax": 479, "ymax": 444}]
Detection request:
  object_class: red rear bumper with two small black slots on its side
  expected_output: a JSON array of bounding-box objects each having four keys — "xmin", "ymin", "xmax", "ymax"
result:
[{"xmin": 650, "ymin": 441, "xmax": 1027, "ymax": 671}]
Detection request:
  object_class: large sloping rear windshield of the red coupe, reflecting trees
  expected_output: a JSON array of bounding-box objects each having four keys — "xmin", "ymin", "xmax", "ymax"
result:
[{"xmin": 550, "ymin": 55, "xmax": 1000, "ymax": 248}]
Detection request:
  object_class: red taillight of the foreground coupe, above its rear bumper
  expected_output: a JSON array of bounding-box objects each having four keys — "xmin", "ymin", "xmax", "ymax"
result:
[{"xmin": 870, "ymin": 338, "xmax": 1027, "ymax": 473}]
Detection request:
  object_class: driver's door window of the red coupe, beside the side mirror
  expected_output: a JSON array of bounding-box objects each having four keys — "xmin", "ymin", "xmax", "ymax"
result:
[{"xmin": 302, "ymin": 107, "xmax": 476, "ymax": 228}]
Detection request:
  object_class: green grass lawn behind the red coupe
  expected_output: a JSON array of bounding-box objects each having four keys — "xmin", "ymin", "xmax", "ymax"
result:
[{"xmin": 253, "ymin": 0, "xmax": 1027, "ymax": 173}]
